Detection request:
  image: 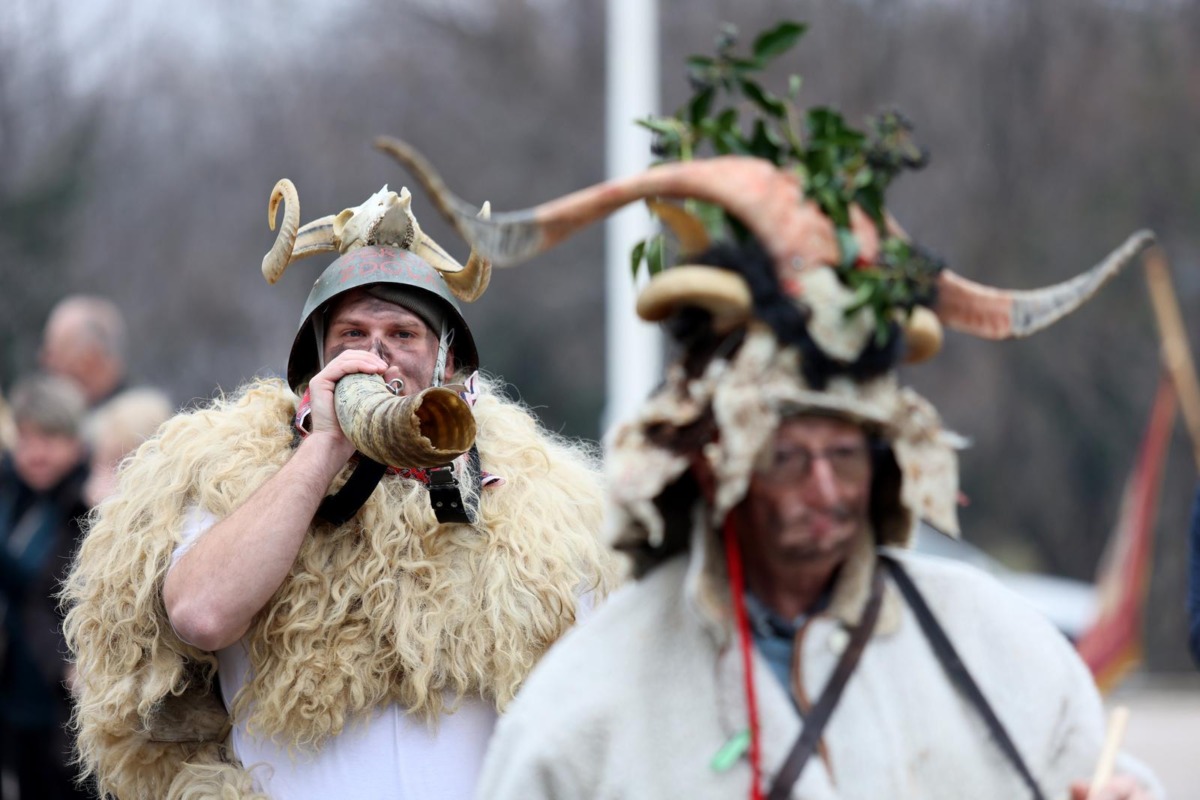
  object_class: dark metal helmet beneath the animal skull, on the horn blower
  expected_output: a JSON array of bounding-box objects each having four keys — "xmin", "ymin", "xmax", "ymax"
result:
[{"xmin": 288, "ymin": 245, "xmax": 479, "ymax": 392}]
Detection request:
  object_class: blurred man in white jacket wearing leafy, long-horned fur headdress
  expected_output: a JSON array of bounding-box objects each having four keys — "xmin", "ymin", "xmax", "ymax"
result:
[{"xmin": 367, "ymin": 24, "xmax": 1157, "ymax": 800}]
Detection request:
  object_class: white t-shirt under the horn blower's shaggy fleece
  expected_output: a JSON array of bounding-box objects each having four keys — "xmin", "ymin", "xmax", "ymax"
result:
[{"xmin": 172, "ymin": 509, "xmax": 497, "ymax": 800}]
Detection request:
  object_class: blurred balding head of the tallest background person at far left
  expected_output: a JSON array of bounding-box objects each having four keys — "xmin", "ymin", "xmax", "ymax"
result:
[{"xmin": 40, "ymin": 295, "xmax": 126, "ymax": 408}]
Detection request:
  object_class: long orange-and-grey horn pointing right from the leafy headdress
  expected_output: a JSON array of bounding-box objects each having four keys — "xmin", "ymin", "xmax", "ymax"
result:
[{"xmin": 934, "ymin": 230, "xmax": 1154, "ymax": 339}]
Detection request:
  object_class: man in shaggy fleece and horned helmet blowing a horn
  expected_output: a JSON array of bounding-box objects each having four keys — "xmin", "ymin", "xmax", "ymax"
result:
[{"xmin": 64, "ymin": 181, "xmax": 614, "ymax": 799}]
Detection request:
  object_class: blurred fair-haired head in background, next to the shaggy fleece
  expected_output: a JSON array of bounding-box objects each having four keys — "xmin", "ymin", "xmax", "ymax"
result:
[{"xmin": 84, "ymin": 387, "xmax": 174, "ymax": 506}]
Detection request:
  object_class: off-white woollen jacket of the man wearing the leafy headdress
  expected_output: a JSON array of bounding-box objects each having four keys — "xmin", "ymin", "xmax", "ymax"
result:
[{"xmin": 476, "ymin": 527, "xmax": 1152, "ymax": 800}]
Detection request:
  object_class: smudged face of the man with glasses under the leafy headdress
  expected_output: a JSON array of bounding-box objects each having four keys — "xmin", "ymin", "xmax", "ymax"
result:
[{"xmin": 733, "ymin": 416, "xmax": 871, "ymax": 566}]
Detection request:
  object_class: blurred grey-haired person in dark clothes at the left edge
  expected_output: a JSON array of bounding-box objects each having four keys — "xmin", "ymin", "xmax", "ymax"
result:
[{"xmin": 0, "ymin": 375, "xmax": 88, "ymax": 800}]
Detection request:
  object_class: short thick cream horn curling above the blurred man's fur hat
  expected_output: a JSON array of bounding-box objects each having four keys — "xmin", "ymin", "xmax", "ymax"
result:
[{"xmin": 637, "ymin": 264, "xmax": 754, "ymax": 333}]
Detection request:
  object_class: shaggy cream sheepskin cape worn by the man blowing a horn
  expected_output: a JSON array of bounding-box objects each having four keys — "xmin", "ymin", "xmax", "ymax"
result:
[{"xmin": 64, "ymin": 380, "xmax": 616, "ymax": 798}]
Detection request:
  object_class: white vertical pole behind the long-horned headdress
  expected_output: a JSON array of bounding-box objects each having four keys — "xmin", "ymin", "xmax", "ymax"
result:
[{"xmin": 601, "ymin": 0, "xmax": 662, "ymax": 437}]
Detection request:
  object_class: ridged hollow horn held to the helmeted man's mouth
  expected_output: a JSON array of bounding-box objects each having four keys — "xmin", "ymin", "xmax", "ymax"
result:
[{"xmin": 334, "ymin": 373, "xmax": 475, "ymax": 468}]
